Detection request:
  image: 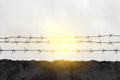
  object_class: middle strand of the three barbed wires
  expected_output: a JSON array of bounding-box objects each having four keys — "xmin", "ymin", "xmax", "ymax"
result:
[{"xmin": 0, "ymin": 40, "xmax": 120, "ymax": 45}]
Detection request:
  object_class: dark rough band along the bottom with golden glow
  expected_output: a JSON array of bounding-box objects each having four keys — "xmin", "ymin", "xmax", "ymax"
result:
[{"xmin": 0, "ymin": 60, "xmax": 120, "ymax": 80}]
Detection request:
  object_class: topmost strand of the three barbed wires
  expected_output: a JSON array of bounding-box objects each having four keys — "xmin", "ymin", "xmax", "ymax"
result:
[{"xmin": 0, "ymin": 34, "xmax": 120, "ymax": 40}]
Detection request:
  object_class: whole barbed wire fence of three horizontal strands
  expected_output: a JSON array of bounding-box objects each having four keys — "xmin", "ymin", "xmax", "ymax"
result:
[{"xmin": 0, "ymin": 34, "xmax": 120, "ymax": 53}]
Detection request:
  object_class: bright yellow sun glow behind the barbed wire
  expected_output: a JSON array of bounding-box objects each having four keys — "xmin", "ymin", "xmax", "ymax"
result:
[{"xmin": 44, "ymin": 20, "xmax": 77, "ymax": 59}]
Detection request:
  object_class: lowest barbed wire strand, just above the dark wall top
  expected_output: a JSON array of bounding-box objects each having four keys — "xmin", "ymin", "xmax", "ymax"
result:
[{"xmin": 0, "ymin": 47, "xmax": 120, "ymax": 54}]
